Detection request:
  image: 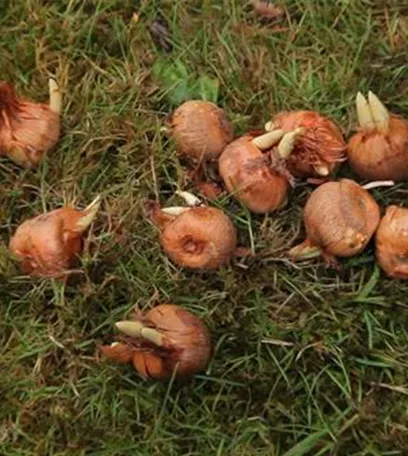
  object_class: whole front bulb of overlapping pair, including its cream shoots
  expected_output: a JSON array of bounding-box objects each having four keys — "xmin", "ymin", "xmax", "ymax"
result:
[{"xmin": 219, "ymin": 129, "xmax": 302, "ymax": 214}]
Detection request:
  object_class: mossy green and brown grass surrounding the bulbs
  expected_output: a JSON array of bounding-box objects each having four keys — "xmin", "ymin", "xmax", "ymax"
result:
[{"xmin": 0, "ymin": 0, "xmax": 408, "ymax": 456}]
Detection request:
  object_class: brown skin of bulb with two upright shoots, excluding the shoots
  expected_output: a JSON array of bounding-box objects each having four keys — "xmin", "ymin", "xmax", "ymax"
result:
[{"xmin": 348, "ymin": 117, "xmax": 408, "ymax": 181}]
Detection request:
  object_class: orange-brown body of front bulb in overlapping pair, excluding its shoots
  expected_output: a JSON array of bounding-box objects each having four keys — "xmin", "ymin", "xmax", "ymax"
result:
[{"xmin": 219, "ymin": 136, "xmax": 289, "ymax": 214}]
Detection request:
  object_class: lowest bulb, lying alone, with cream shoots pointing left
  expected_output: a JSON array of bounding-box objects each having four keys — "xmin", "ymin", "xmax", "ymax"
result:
[{"xmin": 100, "ymin": 304, "xmax": 212, "ymax": 380}]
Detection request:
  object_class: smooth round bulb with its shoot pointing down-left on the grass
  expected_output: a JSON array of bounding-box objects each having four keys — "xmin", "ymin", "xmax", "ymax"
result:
[{"xmin": 289, "ymin": 179, "xmax": 380, "ymax": 261}]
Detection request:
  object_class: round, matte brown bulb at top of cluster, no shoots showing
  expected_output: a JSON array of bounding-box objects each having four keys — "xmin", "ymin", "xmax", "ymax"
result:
[{"xmin": 170, "ymin": 100, "xmax": 233, "ymax": 162}]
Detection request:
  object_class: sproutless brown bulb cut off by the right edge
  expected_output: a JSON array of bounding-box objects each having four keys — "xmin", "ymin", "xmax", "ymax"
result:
[{"xmin": 375, "ymin": 206, "xmax": 408, "ymax": 279}]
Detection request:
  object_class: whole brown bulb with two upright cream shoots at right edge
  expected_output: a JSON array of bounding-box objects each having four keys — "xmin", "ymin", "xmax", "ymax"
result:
[{"xmin": 348, "ymin": 92, "xmax": 408, "ymax": 181}]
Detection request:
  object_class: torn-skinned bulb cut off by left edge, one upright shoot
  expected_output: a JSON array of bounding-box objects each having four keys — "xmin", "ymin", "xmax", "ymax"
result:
[{"xmin": 0, "ymin": 79, "xmax": 61, "ymax": 168}]
